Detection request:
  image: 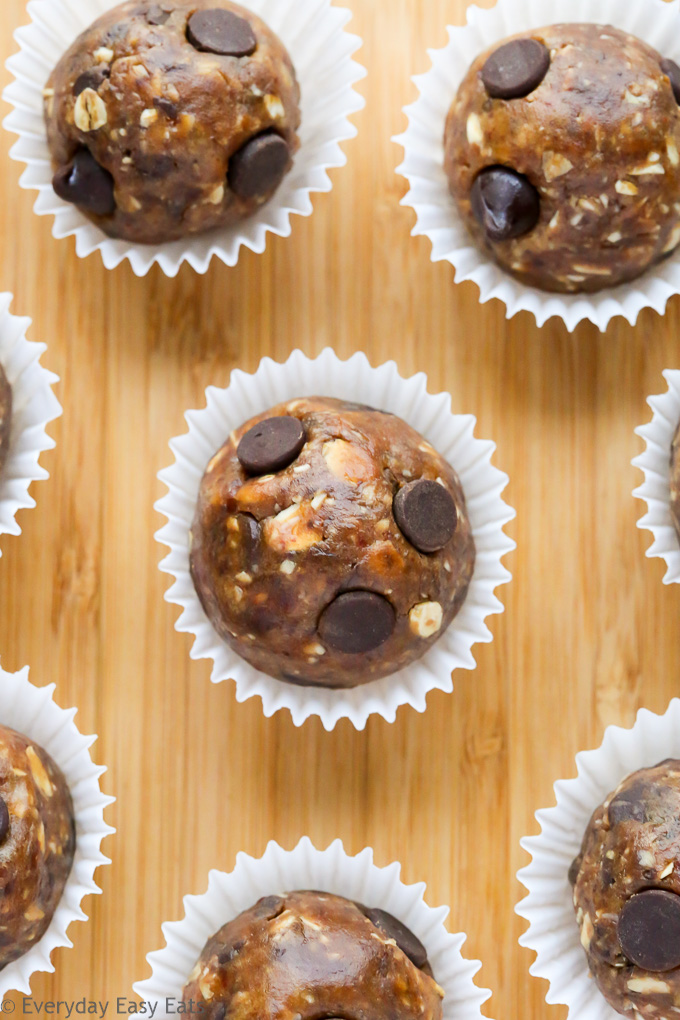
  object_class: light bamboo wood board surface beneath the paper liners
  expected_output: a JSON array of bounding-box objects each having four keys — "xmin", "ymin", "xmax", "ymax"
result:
[{"xmin": 0, "ymin": 0, "xmax": 680, "ymax": 1020}]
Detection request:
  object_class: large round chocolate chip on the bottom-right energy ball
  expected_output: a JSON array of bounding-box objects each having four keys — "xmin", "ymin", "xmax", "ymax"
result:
[{"xmin": 618, "ymin": 889, "xmax": 680, "ymax": 973}]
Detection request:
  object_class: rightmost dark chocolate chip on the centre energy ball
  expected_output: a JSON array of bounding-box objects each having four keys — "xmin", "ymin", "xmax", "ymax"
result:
[{"xmin": 394, "ymin": 478, "xmax": 458, "ymax": 553}]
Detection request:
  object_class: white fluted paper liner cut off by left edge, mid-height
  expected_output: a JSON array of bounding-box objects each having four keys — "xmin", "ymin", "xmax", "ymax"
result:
[{"xmin": 0, "ymin": 294, "xmax": 61, "ymax": 555}]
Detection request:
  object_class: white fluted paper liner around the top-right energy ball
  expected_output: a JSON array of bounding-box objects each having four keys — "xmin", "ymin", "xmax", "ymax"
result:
[{"xmin": 394, "ymin": 0, "xmax": 680, "ymax": 332}]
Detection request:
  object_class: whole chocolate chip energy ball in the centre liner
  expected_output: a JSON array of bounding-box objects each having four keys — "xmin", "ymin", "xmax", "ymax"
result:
[{"xmin": 191, "ymin": 397, "xmax": 475, "ymax": 687}]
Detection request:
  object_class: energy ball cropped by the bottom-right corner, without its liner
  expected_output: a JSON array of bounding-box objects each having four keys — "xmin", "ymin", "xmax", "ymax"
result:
[{"xmin": 570, "ymin": 760, "xmax": 680, "ymax": 1020}]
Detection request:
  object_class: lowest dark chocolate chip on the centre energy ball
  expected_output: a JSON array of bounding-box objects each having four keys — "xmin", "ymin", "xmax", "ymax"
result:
[{"xmin": 319, "ymin": 591, "xmax": 397, "ymax": 655}]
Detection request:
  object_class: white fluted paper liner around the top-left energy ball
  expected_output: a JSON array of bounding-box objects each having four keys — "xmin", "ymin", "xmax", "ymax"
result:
[{"xmin": 3, "ymin": 0, "xmax": 366, "ymax": 276}]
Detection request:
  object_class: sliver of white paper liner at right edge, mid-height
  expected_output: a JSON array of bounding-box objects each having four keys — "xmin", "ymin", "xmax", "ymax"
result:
[{"xmin": 633, "ymin": 368, "xmax": 680, "ymax": 584}]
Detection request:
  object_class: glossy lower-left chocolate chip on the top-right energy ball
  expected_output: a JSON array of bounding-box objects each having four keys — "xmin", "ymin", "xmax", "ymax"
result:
[{"xmin": 471, "ymin": 166, "xmax": 540, "ymax": 241}]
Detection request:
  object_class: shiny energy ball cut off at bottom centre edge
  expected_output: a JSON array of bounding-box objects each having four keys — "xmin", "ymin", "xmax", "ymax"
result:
[{"xmin": 182, "ymin": 893, "xmax": 443, "ymax": 1020}]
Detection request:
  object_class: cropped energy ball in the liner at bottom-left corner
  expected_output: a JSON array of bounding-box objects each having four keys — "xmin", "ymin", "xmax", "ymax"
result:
[{"xmin": 0, "ymin": 726, "xmax": 75, "ymax": 969}]
